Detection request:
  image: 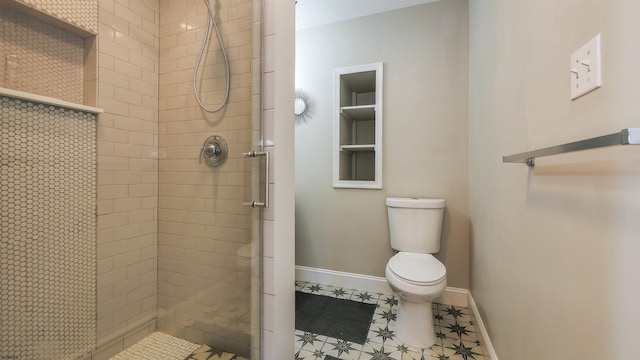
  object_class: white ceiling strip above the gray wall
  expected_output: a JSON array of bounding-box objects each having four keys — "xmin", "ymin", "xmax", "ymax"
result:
[{"xmin": 296, "ymin": 0, "xmax": 438, "ymax": 30}]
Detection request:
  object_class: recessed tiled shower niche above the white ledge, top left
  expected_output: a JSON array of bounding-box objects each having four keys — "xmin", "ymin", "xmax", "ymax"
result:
[{"xmin": 0, "ymin": 0, "xmax": 98, "ymax": 106}]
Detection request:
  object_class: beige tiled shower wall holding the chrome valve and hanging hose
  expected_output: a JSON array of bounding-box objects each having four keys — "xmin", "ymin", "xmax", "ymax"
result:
[{"xmin": 158, "ymin": 0, "xmax": 259, "ymax": 356}]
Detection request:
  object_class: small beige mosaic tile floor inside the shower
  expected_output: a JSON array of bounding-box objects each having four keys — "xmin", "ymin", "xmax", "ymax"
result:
[{"xmin": 109, "ymin": 332, "xmax": 200, "ymax": 360}]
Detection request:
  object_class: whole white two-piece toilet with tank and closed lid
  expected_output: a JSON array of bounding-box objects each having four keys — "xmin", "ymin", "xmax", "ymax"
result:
[{"xmin": 385, "ymin": 198, "xmax": 447, "ymax": 348}]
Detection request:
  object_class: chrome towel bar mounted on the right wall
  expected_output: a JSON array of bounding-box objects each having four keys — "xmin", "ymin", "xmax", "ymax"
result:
[{"xmin": 502, "ymin": 128, "xmax": 640, "ymax": 167}]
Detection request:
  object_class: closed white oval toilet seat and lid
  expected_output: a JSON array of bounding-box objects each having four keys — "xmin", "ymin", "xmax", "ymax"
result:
[{"xmin": 387, "ymin": 252, "xmax": 447, "ymax": 286}]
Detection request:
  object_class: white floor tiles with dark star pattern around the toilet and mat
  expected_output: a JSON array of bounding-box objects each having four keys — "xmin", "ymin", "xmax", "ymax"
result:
[{"xmin": 295, "ymin": 281, "xmax": 489, "ymax": 360}]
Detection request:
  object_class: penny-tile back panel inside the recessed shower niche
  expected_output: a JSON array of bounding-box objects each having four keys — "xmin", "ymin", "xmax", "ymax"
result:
[{"xmin": 0, "ymin": 7, "xmax": 84, "ymax": 104}]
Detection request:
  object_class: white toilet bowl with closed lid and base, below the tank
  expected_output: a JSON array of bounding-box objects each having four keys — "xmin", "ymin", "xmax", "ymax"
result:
[{"xmin": 385, "ymin": 252, "xmax": 447, "ymax": 348}]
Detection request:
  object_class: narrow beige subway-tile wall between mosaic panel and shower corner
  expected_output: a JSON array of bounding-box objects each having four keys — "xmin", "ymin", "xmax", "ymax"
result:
[{"xmin": 94, "ymin": 0, "xmax": 160, "ymax": 358}]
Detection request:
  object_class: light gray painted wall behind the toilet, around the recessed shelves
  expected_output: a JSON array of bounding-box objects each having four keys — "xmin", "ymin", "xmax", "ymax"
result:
[{"xmin": 295, "ymin": 0, "xmax": 469, "ymax": 288}]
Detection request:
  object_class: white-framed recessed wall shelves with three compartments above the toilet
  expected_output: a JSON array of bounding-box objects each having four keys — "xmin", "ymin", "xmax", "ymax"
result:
[{"xmin": 333, "ymin": 63, "xmax": 382, "ymax": 189}]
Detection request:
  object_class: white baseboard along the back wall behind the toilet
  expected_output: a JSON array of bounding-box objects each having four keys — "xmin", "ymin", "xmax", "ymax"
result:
[{"xmin": 296, "ymin": 265, "xmax": 469, "ymax": 307}]
